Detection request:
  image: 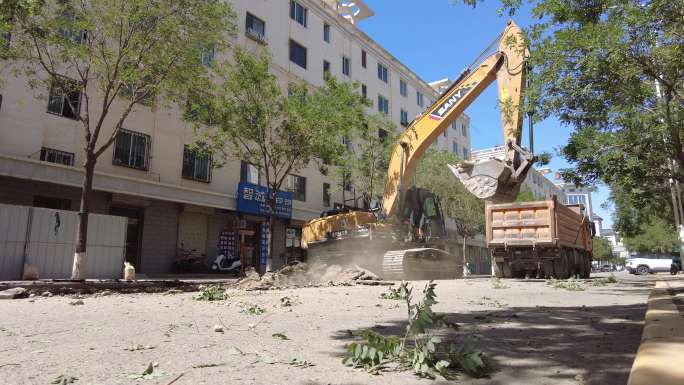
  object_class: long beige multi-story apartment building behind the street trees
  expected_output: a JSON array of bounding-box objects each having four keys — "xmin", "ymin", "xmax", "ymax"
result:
[{"xmin": 0, "ymin": 0, "xmax": 470, "ymax": 274}]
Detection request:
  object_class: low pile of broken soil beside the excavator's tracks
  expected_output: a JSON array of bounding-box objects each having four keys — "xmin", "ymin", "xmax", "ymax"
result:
[{"xmin": 236, "ymin": 263, "xmax": 380, "ymax": 290}]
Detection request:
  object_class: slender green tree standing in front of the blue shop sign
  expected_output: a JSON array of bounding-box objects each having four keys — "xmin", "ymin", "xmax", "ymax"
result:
[{"xmin": 196, "ymin": 47, "xmax": 365, "ymax": 270}]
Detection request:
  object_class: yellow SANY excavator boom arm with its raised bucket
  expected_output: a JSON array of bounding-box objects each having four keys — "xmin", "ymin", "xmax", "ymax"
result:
[{"xmin": 383, "ymin": 22, "xmax": 531, "ymax": 215}]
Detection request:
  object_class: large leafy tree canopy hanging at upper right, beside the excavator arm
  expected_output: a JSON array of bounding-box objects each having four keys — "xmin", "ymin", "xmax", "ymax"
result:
[{"xmin": 465, "ymin": 0, "xmax": 684, "ymax": 226}]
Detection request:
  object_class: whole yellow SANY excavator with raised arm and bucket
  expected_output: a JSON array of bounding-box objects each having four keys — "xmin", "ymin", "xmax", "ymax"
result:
[{"xmin": 302, "ymin": 21, "xmax": 534, "ymax": 279}]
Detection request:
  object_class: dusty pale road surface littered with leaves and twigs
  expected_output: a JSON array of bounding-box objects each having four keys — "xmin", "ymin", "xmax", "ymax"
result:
[{"xmin": 0, "ymin": 273, "xmax": 653, "ymax": 385}]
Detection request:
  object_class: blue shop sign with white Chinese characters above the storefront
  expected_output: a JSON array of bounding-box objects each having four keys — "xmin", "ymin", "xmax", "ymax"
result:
[{"xmin": 237, "ymin": 182, "xmax": 294, "ymax": 219}]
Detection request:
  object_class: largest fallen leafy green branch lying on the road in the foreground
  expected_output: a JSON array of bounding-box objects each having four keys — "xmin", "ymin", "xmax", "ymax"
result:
[{"xmin": 342, "ymin": 281, "xmax": 491, "ymax": 378}]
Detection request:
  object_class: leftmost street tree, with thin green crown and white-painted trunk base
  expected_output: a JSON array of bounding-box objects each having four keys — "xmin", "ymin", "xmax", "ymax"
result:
[{"xmin": 9, "ymin": 0, "xmax": 234, "ymax": 279}]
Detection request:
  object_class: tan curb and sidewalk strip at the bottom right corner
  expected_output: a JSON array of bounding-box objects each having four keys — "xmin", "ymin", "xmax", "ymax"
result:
[{"xmin": 627, "ymin": 275, "xmax": 684, "ymax": 385}]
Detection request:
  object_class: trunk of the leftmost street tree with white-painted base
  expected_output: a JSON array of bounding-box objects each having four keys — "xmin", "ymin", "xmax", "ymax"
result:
[{"xmin": 71, "ymin": 153, "xmax": 95, "ymax": 279}]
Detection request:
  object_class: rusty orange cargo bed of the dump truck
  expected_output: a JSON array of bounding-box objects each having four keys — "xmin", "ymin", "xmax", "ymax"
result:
[{"xmin": 486, "ymin": 199, "xmax": 591, "ymax": 250}]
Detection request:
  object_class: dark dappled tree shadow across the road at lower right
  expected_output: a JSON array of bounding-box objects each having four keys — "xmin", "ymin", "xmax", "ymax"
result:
[{"xmin": 333, "ymin": 302, "xmax": 646, "ymax": 385}]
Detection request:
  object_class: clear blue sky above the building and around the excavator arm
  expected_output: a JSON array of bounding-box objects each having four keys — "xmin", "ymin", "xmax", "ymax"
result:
[{"xmin": 358, "ymin": 0, "xmax": 612, "ymax": 227}]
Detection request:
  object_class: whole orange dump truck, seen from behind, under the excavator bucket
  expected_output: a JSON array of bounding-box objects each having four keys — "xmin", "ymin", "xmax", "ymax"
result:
[{"xmin": 485, "ymin": 196, "xmax": 595, "ymax": 279}]
